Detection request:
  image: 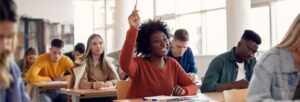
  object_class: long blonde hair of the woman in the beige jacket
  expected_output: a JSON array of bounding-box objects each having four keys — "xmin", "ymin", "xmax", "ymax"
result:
[{"xmin": 78, "ymin": 34, "xmax": 110, "ymax": 79}]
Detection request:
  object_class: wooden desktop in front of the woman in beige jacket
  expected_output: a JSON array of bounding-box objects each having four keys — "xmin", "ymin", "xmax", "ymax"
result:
[{"xmin": 61, "ymin": 89, "xmax": 117, "ymax": 96}]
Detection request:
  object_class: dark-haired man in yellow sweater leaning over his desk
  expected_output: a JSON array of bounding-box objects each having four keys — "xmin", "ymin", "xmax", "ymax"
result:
[{"xmin": 25, "ymin": 39, "xmax": 73, "ymax": 102}]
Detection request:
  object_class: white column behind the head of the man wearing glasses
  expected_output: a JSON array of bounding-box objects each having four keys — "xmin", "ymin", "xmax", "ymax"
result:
[{"xmin": 226, "ymin": 0, "xmax": 251, "ymax": 49}]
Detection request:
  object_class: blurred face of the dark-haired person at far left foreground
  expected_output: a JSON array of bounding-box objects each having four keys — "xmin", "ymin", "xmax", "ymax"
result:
[{"xmin": 0, "ymin": 21, "xmax": 15, "ymax": 54}]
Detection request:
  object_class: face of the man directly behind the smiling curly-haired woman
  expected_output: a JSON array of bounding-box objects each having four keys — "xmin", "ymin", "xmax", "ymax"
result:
[{"xmin": 172, "ymin": 39, "xmax": 188, "ymax": 57}]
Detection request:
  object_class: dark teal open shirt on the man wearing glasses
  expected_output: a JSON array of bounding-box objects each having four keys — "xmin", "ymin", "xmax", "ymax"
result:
[{"xmin": 201, "ymin": 48, "xmax": 256, "ymax": 93}]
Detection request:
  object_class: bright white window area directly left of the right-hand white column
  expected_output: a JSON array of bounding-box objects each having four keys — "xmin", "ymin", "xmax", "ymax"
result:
[{"xmin": 202, "ymin": 9, "xmax": 227, "ymax": 55}]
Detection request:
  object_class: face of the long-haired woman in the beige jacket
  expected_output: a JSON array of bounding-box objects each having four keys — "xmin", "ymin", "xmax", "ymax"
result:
[{"xmin": 91, "ymin": 37, "xmax": 104, "ymax": 56}]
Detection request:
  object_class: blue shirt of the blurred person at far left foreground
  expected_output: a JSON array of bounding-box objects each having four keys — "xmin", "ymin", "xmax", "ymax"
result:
[{"xmin": 0, "ymin": 59, "xmax": 30, "ymax": 102}]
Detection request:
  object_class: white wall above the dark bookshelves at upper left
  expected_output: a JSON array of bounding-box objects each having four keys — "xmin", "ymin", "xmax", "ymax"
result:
[{"xmin": 15, "ymin": 0, "xmax": 74, "ymax": 24}]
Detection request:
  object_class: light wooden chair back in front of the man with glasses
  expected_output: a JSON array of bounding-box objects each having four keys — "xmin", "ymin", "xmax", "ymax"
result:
[{"xmin": 223, "ymin": 89, "xmax": 248, "ymax": 102}]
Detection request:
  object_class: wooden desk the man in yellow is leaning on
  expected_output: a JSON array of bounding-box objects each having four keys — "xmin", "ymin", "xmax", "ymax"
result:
[{"xmin": 28, "ymin": 81, "xmax": 68, "ymax": 102}]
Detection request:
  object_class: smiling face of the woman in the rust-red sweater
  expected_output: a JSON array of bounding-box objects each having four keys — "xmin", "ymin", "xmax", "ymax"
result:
[{"xmin": 150, "ymin": 31, "xmax": 169, "ymax": 57}]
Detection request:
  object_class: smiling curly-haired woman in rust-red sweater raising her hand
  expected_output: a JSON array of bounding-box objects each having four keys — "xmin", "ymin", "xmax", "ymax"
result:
[{"xmin": 120, "ymin": 9, "xmax": 197, "ymax": 98}]
